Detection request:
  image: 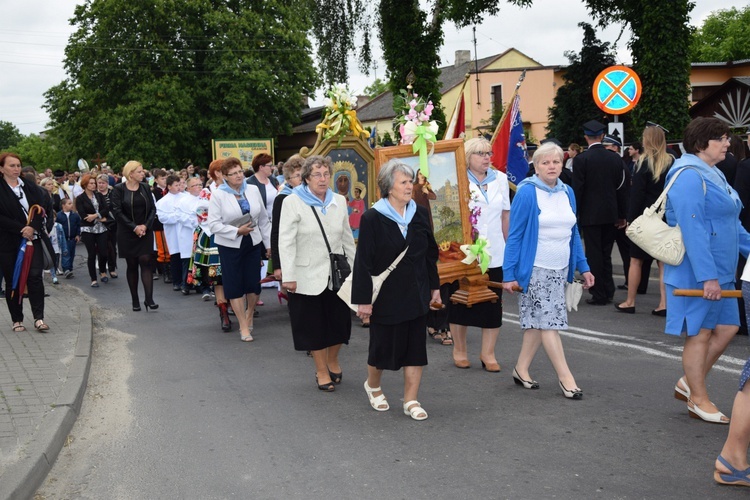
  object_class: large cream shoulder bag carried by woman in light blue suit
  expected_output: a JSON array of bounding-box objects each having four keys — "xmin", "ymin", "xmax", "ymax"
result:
[{"xmin": 625, "ymin": 167, "xmax": 706, "ymax": 266}]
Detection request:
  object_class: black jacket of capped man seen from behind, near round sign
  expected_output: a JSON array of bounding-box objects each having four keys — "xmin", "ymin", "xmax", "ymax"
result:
[{"xmin": 573, "ymin": 144, "xmax": 629, "ymax": 226}]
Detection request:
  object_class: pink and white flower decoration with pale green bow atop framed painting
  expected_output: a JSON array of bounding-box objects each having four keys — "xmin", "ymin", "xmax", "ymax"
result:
[{"xmin": 395, "ymin": 89, "xmax": 438, "ymax": 177}]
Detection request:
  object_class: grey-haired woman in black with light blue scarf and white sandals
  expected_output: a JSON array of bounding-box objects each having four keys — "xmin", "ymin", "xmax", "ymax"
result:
[{"xmin": 352, "ymin": 160, "xmax": 441, "ymax": 420}]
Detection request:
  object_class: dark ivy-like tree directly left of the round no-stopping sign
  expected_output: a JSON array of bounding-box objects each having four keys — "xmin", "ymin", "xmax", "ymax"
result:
[{"xmin": 547, "ymin": 23, "xmax": 627, "ymax": 145}]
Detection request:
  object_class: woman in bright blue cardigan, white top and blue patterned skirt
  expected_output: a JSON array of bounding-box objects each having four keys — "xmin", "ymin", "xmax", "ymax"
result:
[{"xmin": 503, "ymin": 142, "xmax": 594, "ymax": 399}]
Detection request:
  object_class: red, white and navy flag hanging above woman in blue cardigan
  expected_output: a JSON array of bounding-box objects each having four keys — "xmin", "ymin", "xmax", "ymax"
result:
[{"xmin": 492, "ymin": 94, "xmax": 529, "ymax": 184}]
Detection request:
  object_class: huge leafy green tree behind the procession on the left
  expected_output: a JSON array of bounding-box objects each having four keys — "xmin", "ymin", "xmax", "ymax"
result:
[{"xmin": 45, "ymin": 0, "xmax": 319, "ymax": 167}]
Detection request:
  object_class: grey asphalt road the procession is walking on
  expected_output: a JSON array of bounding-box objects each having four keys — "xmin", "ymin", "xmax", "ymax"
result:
[{"xmin": 37, "ymin": 266, "xmax": 750, "ymax": 500}]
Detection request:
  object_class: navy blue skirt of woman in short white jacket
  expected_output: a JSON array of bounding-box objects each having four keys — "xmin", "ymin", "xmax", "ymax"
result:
[{"xmin": 216, "ymin": 236, "xmax": 263, "ymax": 299}]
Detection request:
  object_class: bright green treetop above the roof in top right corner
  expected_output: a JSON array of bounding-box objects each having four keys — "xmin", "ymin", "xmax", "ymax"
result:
[{"xmin": 690, "ymin": 5, "xmax": 750, "ymax": 62}]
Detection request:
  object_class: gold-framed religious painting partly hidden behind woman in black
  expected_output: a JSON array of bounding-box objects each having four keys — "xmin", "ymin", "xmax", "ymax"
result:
[{"xmin": 373, "ymin": 139, "xmax": 471, "ymax": 263}]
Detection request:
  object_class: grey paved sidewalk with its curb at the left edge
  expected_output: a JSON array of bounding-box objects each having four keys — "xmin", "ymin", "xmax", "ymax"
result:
[{"xmin": 0, "ymin": 282, "xmax": 92, "ymax": 500}]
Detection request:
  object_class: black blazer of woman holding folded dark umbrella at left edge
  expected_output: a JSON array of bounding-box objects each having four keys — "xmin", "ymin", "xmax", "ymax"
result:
[{"xmin": 0, "ymin": 176, "xmax": 55, "ymax": 254}]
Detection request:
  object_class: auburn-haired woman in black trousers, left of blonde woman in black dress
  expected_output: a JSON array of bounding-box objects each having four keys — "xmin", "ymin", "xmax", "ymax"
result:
[{"xmin": 76, "ymin": 174, "xmax": 109, "ymax": 288}]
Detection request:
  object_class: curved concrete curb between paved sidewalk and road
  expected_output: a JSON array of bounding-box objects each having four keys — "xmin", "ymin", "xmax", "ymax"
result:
[{"xmin": 0, "ymin": 306, "xmax": 93, "ymax": 500}]
